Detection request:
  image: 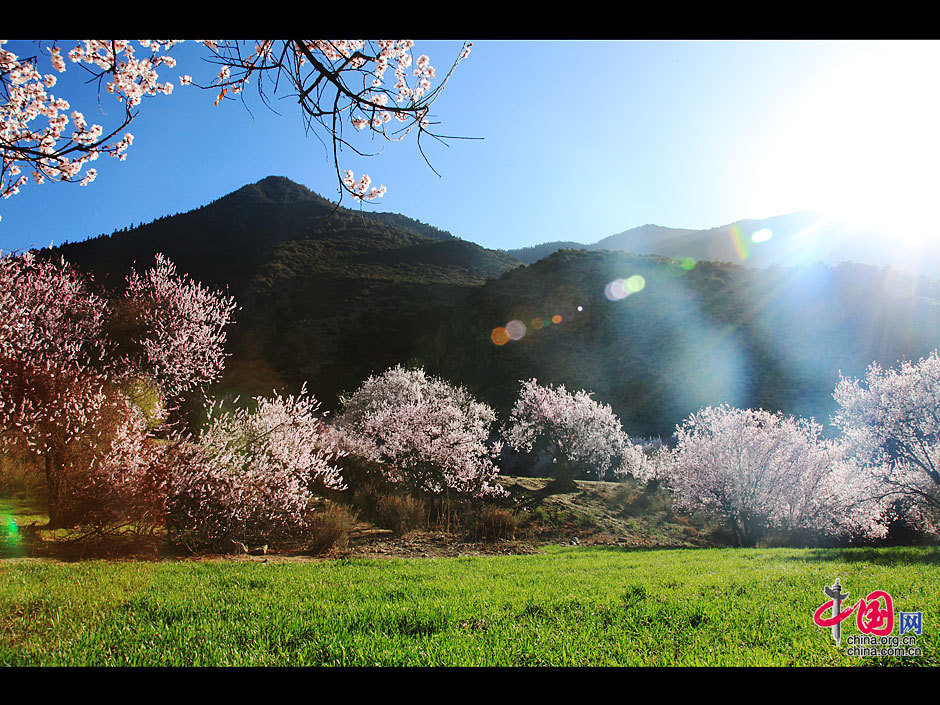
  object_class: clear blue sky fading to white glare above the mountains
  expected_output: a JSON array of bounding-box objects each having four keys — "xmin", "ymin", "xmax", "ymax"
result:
[{"xmin": 0, "ymin": 37, "xmax": 940, "ymax": 251}]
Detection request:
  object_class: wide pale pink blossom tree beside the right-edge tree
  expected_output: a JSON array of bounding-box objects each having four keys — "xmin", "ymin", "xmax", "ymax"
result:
[{"xmin": 667, "ymin": 406, "xmax": 885, "ymax": 545}]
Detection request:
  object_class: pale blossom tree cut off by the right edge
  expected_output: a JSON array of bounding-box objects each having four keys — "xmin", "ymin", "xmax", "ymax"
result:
[{"xmin": 833, "ymin": 351, "xmax": 940, "ymax": 533}]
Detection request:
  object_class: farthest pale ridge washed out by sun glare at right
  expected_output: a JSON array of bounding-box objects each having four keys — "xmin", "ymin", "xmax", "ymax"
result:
[{"xmin": 507, "ymin": 211, "xmax": 940, "ymax": 279}]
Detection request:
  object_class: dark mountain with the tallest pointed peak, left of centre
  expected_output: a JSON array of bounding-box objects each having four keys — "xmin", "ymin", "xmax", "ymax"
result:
[{"xmin": 46, "ymin": 176, "xmax": 520, "ymax": 408}]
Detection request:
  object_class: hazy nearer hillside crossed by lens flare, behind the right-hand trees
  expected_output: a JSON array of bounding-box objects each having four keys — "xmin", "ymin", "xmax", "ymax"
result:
[{"xmin": 428, "ymin": 250, "xmax": 940, "ymax": 436}]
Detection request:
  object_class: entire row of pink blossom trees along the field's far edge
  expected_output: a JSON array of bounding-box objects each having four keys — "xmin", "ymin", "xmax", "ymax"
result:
[{"xmin": 0, "ymin": 245, "xmax": 940, "ymax": 545}]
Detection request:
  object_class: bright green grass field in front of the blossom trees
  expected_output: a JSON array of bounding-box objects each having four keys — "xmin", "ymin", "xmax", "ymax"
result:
[{"xmin": 0, "ymin": 547, "xmax": 940, "ymax": 666}]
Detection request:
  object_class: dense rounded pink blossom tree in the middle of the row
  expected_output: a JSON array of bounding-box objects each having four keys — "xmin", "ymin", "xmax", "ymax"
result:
[{"xmin": 341, "ymin": 365, "xmax": 502, "ymax": 497}]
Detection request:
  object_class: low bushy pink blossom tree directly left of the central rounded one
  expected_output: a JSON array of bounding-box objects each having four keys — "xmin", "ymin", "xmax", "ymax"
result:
[{"xmin": 167, "ymin": 390, "xmax": 344, "ymax": 547}]
